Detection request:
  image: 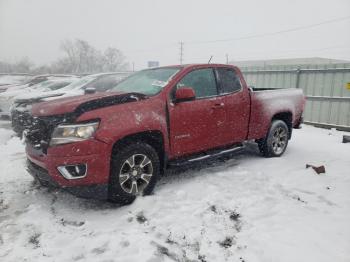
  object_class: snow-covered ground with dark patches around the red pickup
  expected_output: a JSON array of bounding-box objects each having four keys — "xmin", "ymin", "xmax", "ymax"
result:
[{"xmin": 0, "ymin": 122, "xmax": 350, "ymax": 262}]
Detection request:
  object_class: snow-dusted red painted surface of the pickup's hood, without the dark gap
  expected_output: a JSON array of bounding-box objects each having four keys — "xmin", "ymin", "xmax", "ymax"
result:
[{"xmin": 32, "ymin": 92, "xmax": 139, "ymax": 116}]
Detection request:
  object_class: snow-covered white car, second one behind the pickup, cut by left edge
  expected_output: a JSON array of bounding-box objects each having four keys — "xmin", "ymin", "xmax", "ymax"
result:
[{"xmin": 0, "ymin": 77, "xmax": 78, "ymax": 118}]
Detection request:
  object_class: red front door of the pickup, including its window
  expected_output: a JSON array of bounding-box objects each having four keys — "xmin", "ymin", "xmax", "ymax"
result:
[{"xmin": 169, "ymin": 68, "xmax": 226, "ymax": 157}]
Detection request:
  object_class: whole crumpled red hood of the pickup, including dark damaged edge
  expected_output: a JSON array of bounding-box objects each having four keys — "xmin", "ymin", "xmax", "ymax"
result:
[{"xmin": 32, "ymin": 92, "xmax": 146, "ymax": 116}]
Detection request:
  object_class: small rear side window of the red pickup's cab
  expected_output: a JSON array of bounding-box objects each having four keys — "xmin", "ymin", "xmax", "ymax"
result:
[{"xmin": 217, "ymin": 68, "xmax": 241, "ymax": 94}]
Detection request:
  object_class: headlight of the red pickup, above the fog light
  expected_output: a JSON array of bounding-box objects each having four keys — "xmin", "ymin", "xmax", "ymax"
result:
[{"xmin": 50, "ymin": 121, "xmax": 99, "ymax": 146}]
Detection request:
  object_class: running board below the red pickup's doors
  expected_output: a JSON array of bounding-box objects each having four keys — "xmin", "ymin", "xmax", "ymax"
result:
[{"xmin": 168, "ymin": 145, "xmax": 244, "ymax": 167}]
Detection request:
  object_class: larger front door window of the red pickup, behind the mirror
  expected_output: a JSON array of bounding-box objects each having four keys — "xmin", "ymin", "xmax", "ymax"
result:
[{"xmin": 177, "ymin": 68, "xmax": 218, "ymax": 98}]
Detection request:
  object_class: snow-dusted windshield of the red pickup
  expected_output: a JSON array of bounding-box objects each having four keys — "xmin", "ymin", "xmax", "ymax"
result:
[{"xmin": 111, "ymin": 67, "xmax": 180, "ymax": 95}]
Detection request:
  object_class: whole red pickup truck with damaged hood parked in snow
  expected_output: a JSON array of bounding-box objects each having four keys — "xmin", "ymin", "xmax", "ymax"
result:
[{"xmin": 25, "ymin": 64, "xmax": 305, "ymax": 203}]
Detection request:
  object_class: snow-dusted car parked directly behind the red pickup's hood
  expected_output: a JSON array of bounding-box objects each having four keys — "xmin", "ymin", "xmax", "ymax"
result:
[{"xmin": 11, "ymin": 72, "xmax": 129, "ymax": 137}]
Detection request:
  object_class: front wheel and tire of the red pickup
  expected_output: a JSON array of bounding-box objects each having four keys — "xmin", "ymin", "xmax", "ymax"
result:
[{"xmin": 108, "ymin": 142, "xmax": 160, "ymax": 205}]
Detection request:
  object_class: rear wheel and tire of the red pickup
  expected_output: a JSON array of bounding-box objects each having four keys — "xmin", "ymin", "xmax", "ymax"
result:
[{"xmin": 257, "ymin": 120, "xmax": 289, "ymax": 157}]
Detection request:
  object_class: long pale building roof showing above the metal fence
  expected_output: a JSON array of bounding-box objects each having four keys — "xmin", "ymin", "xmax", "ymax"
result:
[{"xmin": 230, "ymin": 57, "xmax": 350, "ymax": 67}]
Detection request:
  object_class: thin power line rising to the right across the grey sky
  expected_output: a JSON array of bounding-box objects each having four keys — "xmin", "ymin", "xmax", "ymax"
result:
[{"xmin": 186, "ymin": 16, "xmax": 350, "ymax": 44}]
